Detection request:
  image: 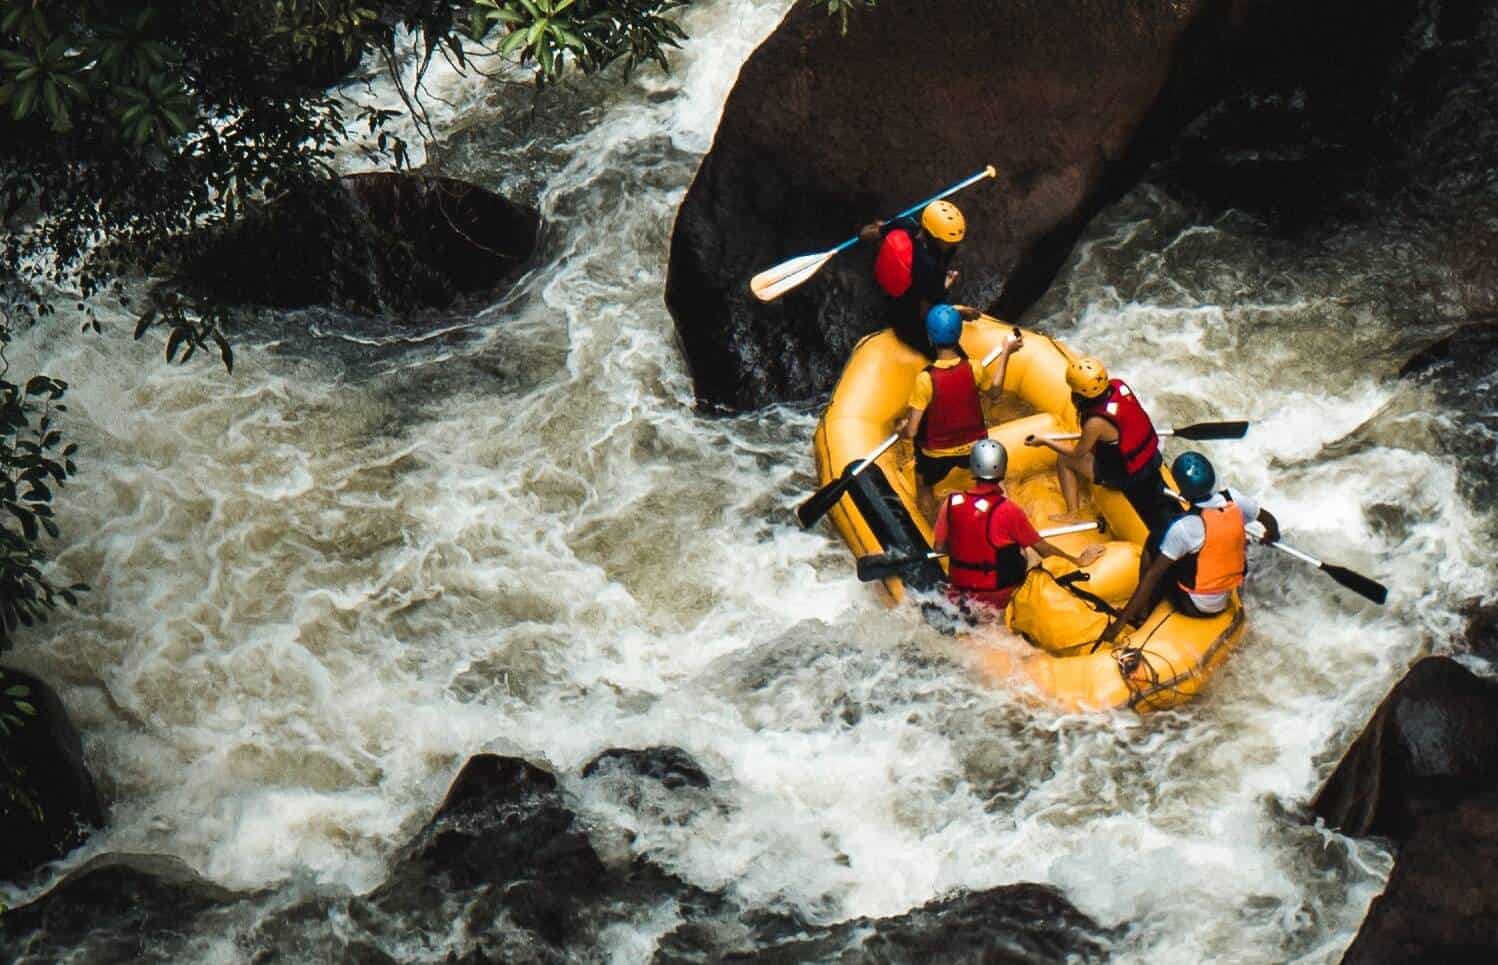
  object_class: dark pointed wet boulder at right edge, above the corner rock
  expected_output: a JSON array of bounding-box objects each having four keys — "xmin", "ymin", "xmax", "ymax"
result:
[{"xmin": 1311, "ymin": 656, "xmax": 1498, "ymax": 839}]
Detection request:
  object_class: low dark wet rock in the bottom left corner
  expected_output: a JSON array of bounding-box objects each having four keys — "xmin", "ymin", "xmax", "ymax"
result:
[{"xmin": 0, "ymin": 854, "xmax": 240, "ymax": 962}]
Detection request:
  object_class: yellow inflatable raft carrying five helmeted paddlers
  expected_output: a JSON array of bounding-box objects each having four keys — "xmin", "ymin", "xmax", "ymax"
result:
[{"xmin": 812, "ymin": 316, "xmax": 1243, "ymax": 712}]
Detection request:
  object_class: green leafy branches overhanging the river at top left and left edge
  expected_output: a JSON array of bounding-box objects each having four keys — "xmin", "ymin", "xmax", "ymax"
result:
[{"xmin": 0, "ymin": 0, "xmax": 873, "ymax": 650}]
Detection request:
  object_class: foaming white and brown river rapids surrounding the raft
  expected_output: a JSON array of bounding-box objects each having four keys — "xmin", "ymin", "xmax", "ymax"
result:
[{"xmin": 9, "ymin": 0, "xmax": 1494, "ymax": 962}]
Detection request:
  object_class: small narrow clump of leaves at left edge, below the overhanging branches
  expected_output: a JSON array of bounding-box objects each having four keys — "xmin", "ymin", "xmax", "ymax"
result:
[{"xmin": 0, "ymin": 325, "xmax": 88, "ymax": 656}]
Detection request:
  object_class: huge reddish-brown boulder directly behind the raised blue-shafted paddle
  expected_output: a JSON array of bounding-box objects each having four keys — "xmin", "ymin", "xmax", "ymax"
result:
[{"xmin": 667, "ymin": 0, "xmax": 1273, "ymax": 406}]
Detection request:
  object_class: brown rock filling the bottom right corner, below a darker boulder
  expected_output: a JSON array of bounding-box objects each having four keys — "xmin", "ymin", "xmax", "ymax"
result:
[{"xmin": 1342, "ymin": 794, "xmax": 1498, "ymax": 965}]
